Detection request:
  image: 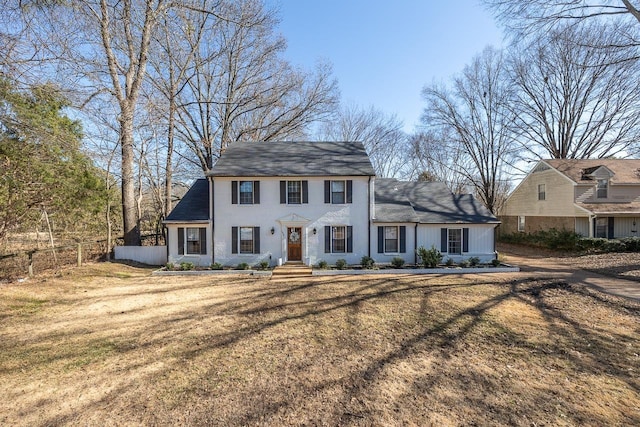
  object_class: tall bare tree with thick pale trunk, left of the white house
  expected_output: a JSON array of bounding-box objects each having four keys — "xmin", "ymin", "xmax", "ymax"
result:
[{"xmin": 4, "ymin": 0, "xmax": 221, "ymax": 245}]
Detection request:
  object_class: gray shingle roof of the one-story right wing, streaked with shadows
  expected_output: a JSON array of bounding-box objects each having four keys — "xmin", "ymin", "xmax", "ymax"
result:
[{"xmin": 375, "ymin": 179, "xmax": 500, "ymax": 224}]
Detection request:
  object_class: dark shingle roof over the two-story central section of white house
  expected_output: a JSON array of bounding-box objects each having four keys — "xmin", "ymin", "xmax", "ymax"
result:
[{"xmin": 209, "ymin": 141, "xmax": 375, "ymax": 177}]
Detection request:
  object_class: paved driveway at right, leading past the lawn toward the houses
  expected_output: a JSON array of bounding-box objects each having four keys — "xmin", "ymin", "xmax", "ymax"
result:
[{"xmin": 501, "ymin": 252, "xmax": 640, "ymax": 301}]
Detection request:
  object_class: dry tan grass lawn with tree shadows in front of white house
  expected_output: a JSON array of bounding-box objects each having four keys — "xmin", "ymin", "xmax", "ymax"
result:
[{"xmin": 0, "ymin": 264, "xmax": 640, "ymax": 426}]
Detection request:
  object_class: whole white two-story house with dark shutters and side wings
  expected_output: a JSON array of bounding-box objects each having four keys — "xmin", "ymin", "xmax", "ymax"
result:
[{"xmin": 165, "ymin": 142, "xmax": 499, "ymax": 265}]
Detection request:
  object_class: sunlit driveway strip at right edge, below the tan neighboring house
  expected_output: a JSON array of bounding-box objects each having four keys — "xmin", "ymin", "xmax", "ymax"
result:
[{"xmin": 500, "ymin": 245, "xmax": 640, "ymax": 300}]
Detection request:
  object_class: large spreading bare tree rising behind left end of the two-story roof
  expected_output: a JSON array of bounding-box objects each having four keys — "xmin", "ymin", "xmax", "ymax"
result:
[{"xmin": 176, "ymin": 0, "xmax": 338, "ymax": 171}]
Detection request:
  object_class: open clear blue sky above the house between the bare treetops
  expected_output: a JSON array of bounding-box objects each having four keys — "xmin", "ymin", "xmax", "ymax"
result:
[{"xmin": 267, "ymin": 0, "xmax": 502, "ymax": 132}]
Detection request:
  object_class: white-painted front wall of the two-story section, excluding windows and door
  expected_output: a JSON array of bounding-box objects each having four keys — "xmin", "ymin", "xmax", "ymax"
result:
[{"xmin": 214, "ymin": 176, "xmax": 369, "ymax": 265}]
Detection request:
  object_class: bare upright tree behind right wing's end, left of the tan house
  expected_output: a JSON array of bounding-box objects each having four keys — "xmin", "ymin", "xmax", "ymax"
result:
[{"xmin": 422, "ymin": 47, "xmax": 513, "ymax": 212}]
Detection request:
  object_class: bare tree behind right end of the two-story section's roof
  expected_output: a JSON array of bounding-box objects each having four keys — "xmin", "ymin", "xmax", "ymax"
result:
[{"xmin": 317, "ymin": 105, "xmax": 410, "ymax": 178}]
